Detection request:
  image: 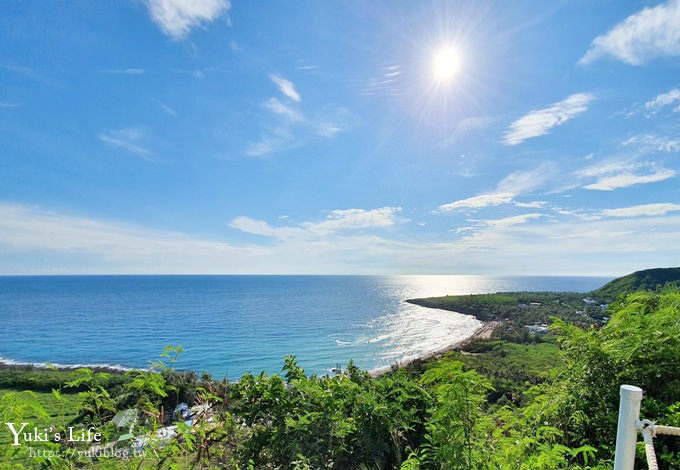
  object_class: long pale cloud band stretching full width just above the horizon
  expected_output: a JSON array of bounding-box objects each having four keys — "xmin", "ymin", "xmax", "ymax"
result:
[{"xmin": 0, "ymin": 202, "xmax": 680, "ymax": 275}]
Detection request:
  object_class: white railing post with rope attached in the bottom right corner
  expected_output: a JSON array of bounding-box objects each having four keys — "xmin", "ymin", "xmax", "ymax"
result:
[{"xmin": 614, "ymin": 385, "xmax": 642, "ymax": 470}]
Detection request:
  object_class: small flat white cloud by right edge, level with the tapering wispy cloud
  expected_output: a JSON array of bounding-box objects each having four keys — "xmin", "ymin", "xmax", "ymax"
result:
[{"xmin": 576, "ymin": 161, "xmax": 677, "ymax": 191}]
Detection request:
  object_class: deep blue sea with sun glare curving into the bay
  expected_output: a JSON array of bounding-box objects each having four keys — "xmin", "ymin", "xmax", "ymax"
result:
[{"xmin": 0, "ymin": 276, "xmax": 610, "ymax": 379}]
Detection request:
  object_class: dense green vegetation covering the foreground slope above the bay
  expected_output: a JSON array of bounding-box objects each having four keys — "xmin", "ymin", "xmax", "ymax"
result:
[{"xmin": 0, "ymin": 288, "xmax": 680, "ymax": 470}]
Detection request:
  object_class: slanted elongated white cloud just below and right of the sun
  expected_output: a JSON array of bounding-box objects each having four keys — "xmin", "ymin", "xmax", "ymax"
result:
[{"xmin": 503, "ymin": 93, "xmax": 595, "ymax": 145}]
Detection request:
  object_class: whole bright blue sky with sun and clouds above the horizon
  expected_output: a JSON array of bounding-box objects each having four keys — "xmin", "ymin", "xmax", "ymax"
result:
[{"xmin": 0, "ymin": 0, "xmax": 680, "ymax": 276}]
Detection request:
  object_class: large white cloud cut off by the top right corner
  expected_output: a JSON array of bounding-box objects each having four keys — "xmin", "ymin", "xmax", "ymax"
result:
[{"xmin": 579, "ymin": 0, "xmax": 680, "ymax": 65}]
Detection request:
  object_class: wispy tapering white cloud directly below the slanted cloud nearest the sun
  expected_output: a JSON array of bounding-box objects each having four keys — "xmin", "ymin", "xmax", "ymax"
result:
[{"xmin": 436, "ymin": 163, "xmax": 556, "ymax": 213}]
